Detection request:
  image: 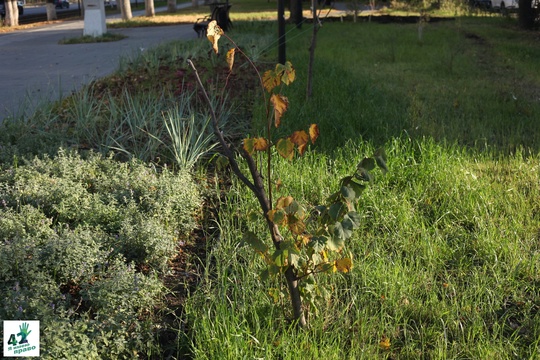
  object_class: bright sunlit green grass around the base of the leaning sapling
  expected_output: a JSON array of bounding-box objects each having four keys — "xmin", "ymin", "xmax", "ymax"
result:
[{"xmin": 182, "ymin": 139, "xmax": 540, "ymax": 359}]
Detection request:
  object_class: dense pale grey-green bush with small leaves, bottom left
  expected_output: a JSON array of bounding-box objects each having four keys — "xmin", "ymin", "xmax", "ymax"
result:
[{"xmin": 0, "ymin": 151, "xmax": 200, "ymax": 358}]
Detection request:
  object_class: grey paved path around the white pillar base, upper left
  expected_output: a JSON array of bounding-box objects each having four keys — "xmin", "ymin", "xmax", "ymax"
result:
[{"xmin": 0, "ymin": 4, "xmax": 196, "ymax": 123}]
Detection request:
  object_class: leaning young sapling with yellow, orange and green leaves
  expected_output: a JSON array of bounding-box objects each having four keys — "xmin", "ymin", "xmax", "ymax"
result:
[{"xmin": 188, "ymin": 21, "xmax": 387, "ymax": 327}]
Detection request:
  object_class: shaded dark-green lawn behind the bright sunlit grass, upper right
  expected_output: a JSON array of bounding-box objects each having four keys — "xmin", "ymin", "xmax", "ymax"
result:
[{"xmin": 258, "ymin": 18, "xmax": 540, "ymax": 153}]
